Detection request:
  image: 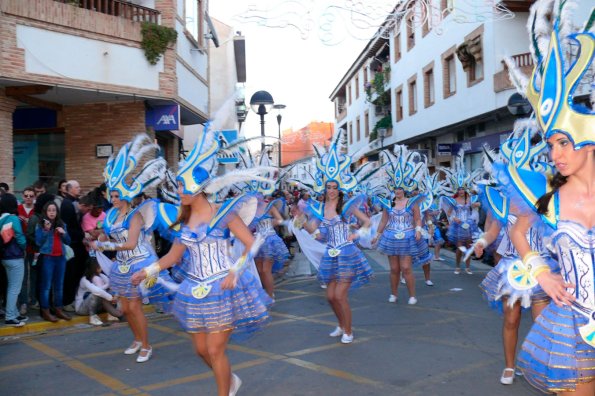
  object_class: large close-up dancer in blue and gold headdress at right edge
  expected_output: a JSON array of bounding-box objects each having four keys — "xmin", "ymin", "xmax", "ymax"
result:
[{"xmin": 503, "ymin": 1, "xmax": 595, "ymax": 396}]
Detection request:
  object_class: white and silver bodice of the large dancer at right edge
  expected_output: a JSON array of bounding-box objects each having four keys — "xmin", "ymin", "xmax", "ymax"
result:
[{"xmin": 552, "ymin": 220, "xmax": 595, "ymax": 309}]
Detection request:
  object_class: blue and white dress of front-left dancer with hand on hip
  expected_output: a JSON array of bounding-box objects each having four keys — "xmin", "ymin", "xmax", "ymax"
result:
[{"xmin": 173, "ymin": 196, "xmax": 272, "ymax": 335}]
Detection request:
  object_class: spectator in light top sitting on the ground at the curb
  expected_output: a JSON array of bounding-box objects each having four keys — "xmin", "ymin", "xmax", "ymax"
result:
[{"xmin": 74, "ymin": 258, "xmax": 123, "ymax": 326}]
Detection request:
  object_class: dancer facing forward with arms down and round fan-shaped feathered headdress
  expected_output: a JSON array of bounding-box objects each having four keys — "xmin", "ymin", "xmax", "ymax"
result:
[{"xmin": 373, "ymin": 145, "xmax": 432, "ymax": 305}]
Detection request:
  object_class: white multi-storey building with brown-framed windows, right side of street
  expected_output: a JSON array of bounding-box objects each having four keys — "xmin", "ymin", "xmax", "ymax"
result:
[{"xmin": 330, "ymin": 0, "xmax": 589, "ymax": 172}]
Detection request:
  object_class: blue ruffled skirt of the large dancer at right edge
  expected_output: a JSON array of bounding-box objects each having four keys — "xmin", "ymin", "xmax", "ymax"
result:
[{"xmin": 518, "ymin": 303, "xmax": 595, "ymax": 393}]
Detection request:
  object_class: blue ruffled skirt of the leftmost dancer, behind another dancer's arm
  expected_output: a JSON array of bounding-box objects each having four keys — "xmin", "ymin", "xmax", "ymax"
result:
[{"xmin": 109, "ymin": 255, "xmax": 172, "ymax": 309}]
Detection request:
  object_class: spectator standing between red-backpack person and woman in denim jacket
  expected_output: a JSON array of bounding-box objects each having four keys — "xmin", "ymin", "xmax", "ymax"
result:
[{"xmin": 17, "ymin": 187, "xmax": 37, "ymax": 315}]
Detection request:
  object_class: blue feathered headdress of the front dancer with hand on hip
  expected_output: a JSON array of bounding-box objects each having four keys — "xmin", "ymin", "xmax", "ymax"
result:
[{"xmin": 176, "ymin": 123, "xmax": 271, "ymax": 195}]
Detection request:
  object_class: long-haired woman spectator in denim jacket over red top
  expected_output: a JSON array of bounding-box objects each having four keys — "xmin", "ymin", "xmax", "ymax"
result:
[{"xmin": 35, "ymin": 201, "xmax": 71, "ymax": 322}]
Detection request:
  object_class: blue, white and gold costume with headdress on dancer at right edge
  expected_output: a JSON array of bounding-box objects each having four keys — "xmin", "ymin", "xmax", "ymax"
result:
[{"xmin": 501, "ymin": 1, "xmax": 595, "ymax": 393}]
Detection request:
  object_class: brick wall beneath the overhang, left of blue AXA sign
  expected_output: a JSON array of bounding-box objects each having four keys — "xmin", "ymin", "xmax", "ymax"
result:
[{"xmin": 62, "ymin": 102, "xmax": 154, "ymax": 192}]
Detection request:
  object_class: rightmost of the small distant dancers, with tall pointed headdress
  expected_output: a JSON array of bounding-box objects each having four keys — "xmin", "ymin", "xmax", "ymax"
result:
[{"xmin": 440, "ymin": 150, "xmax": 479, "ymax": 275}]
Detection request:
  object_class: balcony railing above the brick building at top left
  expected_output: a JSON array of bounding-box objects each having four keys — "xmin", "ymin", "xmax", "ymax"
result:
[{"xmin": 54, "ymin": 0, "xmax": 160, "ymax": 23}]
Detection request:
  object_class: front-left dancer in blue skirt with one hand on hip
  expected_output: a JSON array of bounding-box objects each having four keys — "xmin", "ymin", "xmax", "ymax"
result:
[{"xmin": 133, "ymin": 126, "xmax": 271, "ymax": 396}]
